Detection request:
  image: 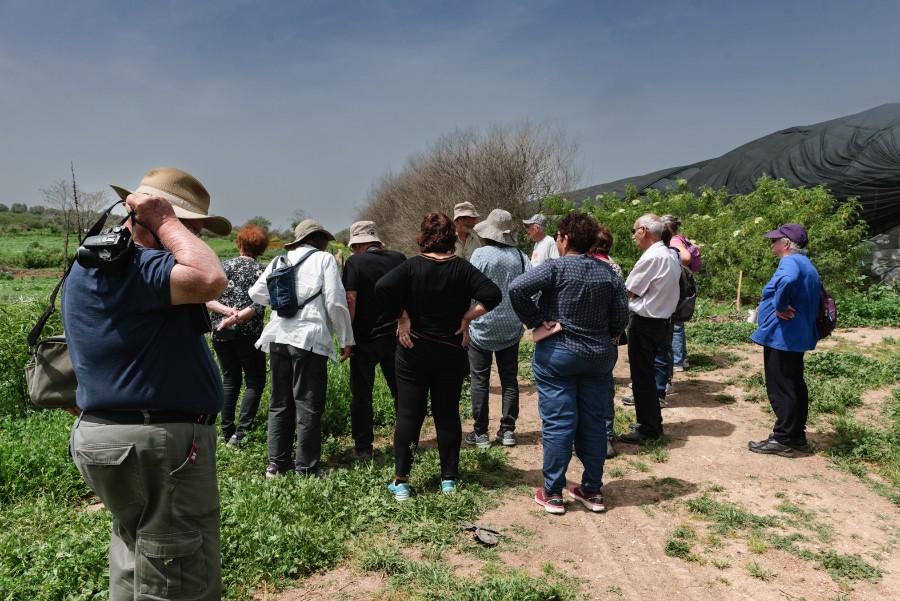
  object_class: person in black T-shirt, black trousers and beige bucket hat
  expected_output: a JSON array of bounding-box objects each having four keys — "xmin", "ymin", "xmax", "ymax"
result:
[{"xmin": 343, "ymin": 221, "xmax": 406, "ymax": 461}]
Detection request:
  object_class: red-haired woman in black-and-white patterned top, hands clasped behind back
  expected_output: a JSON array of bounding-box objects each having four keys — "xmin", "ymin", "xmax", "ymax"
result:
[{"xmin": 206, "ymin": 225, "xmax": 269, "ymax": 448}]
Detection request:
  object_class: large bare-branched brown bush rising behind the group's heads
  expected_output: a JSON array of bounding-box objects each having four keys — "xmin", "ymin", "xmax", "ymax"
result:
[{"xmin": 357, "ymin": 121, "xmax": 580, "ymax": 253}]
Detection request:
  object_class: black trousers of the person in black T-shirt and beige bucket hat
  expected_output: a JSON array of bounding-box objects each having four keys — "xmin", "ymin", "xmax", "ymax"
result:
[{"xmin": 350, "ymin": 336, "xmax": 397, "ymax": 451}]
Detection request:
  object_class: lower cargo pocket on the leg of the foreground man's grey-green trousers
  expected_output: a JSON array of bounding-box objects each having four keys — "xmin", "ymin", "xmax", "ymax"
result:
[{"xmin": 135, "ymin": 530, "xmax": 207, "ymax": 598}]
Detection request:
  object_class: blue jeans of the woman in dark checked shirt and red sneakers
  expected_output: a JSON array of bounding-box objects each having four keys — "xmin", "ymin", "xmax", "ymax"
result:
[{"xmin": 531, "ymin": 339, "xmax": 615, "ymax": 495}]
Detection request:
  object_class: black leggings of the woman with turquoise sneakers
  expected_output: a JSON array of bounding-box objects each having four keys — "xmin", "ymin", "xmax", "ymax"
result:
[{"xmin": 394, "ymin": 338, "xmax": 469, "ymax": 479}]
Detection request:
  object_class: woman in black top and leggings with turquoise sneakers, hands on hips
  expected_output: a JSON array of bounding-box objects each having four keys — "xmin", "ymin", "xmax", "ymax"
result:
[{"xmin": 375, "ymin": 212, "xmax": 502, "ymax": 501}]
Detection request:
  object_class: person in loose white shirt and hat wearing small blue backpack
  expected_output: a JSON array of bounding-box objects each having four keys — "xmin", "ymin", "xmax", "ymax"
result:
[{"xmin": 248, "ymin": 219, "xmax": 355, "ymax": 478}]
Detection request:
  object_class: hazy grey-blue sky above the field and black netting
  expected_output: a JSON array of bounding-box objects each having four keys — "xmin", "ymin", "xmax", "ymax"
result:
[{"xmin": 0, "ymin": 0, "xmax": 900, "ymax": 231}]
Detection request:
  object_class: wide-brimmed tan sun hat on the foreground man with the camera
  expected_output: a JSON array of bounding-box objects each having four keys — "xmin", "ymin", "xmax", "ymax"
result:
[{"xmin": 109, "ymin": 167, "xmax": 231, "ymax": 236}]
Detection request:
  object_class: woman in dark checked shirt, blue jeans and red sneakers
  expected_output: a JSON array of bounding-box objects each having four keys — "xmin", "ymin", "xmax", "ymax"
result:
[{"xmin": 509, "ymin": 211, "xmax": 628, "ymax": 514}]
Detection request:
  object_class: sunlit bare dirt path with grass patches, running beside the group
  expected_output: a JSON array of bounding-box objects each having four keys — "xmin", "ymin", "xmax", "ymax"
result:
[{"xmin": 279, "ymin": 328, "xmax": 900, "ymax": 601}]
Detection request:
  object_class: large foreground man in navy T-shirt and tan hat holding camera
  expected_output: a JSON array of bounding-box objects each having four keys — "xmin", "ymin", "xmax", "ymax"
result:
[{"xmin": 61, "ymin": 168, "xmax": 231, "ymax": 599}]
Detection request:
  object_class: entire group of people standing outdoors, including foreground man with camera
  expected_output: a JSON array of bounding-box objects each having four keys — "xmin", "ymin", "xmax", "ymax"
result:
[{"xmin": 61, "ymin": 168, "xmax": 819, "ymax": 599}]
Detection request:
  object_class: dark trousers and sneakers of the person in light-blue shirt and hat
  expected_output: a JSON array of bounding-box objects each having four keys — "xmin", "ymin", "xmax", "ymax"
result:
[{"xmin": 465, "ymin": 342, "xmax": 519, "ymax": 448}]
